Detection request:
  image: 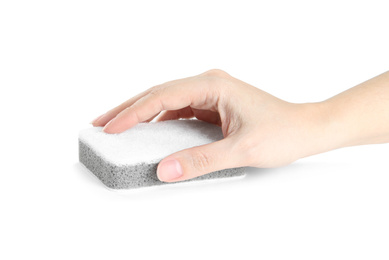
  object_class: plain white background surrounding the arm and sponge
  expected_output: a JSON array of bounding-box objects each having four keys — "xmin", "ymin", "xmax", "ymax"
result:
[{"xmin": 0, "ymin": 0, "xmax": 389, "ymax": 259}]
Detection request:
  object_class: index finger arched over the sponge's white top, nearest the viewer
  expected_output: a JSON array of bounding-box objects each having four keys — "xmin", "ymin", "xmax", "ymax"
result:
[{"xmin": 104, "ymin": 79, "xmax": 218, "ymax": 133}]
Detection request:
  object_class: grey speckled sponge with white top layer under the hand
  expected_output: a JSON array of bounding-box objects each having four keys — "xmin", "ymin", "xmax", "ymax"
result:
[{"xmin": 79, "ymin": 120, "xmax": 244, "ymax": 189}]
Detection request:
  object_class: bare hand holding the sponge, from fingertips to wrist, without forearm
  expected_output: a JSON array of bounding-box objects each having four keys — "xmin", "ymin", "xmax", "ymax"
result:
[{"xmin": 92, "ymin": 70, "xmax": 325, "ymax": 182}]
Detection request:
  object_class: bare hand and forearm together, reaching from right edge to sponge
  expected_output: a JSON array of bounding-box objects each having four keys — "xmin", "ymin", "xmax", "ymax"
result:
[{"xmin": 92, "ymin": 69, "xmax": 389, "ymax": 182}]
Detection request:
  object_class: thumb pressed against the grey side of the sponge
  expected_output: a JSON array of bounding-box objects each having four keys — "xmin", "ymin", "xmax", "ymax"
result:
[{"xmin": 157, "ymin": 138, "xmax": 238, "ymax": 182}]
